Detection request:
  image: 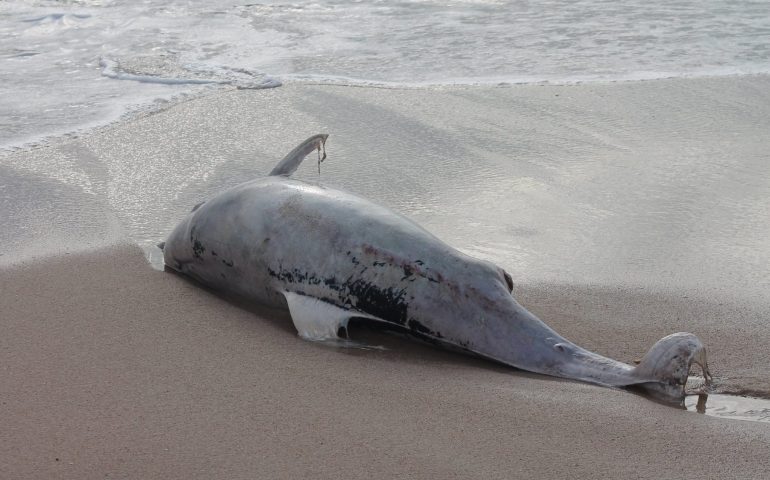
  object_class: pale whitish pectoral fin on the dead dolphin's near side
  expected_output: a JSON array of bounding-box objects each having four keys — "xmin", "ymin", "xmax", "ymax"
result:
[{"xmin": 283, "ymin": 292, "xmax": 366, "ymax": 341}]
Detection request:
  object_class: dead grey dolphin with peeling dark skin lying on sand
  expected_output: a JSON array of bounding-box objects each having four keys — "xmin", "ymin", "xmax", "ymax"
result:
[{"xmin": 164, "ymin": 135, "xmax": 710, "ymax": 403}]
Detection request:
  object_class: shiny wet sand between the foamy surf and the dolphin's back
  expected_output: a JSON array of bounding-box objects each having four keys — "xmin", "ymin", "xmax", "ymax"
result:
[{"xmin": 6, "ymin": 78, "xmax": 770, "ymax": 302}]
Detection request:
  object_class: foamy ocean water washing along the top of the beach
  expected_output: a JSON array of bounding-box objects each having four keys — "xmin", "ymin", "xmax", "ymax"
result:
[{"xmin": 0, "ymin": 0, "xmax": 770, "ymax": 148}]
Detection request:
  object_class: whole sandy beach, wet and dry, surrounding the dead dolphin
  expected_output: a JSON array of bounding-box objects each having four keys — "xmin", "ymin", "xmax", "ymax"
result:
[{"xmin": 0, "ymin": 76, "xmax": 770, "ymax": 479}]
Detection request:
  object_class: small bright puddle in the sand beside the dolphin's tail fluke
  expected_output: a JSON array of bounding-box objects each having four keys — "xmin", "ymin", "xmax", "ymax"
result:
[{"xmin": 685, "ymin": 394, "xmax": 770, "ymax": 423}]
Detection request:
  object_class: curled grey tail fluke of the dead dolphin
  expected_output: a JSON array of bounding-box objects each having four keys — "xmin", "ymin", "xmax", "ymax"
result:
[{"xmin": 632, "ymin": 333, "xmax": 711, "ymax": 402}]
